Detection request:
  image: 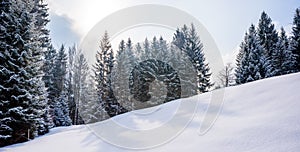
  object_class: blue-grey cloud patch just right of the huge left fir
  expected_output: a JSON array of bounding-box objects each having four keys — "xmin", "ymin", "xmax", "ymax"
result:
[{"xmin": 49, "ymin": 12, "xmax": 81, "ymax": 47}]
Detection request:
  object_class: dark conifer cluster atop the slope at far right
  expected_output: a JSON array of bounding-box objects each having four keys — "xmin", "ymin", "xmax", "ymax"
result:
[{"xmin": 235, "ymin": 9, "xmax": 300, "ymax": 84}]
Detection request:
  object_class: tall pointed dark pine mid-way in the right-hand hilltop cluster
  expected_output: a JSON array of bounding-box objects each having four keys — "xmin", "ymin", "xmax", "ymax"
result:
[{"xmin": 257, "ymin": 12, "xmax": 278, "ymax": 78}]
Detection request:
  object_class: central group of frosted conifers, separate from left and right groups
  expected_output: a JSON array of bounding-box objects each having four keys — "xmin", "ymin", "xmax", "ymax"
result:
[{"xmin": 94, "ymin": 24, "xmax": 213, "ymax": 116}]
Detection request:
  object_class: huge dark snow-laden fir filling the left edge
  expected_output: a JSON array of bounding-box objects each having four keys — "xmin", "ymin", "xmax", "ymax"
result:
[{"xmin": 0, "ymin": 0, "xmax": 49, "ymax": 146}]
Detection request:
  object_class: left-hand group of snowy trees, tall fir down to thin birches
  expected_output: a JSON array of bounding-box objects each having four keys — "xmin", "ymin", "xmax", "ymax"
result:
[{"xmin": 0, "ymin": 0, "xmax": 96, "ymax": 146}]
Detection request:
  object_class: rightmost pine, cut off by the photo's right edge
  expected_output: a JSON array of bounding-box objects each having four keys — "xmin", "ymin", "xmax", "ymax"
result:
[{"xmin": 290, "ymin": 8, "xmax": 300, "ymax": 72}]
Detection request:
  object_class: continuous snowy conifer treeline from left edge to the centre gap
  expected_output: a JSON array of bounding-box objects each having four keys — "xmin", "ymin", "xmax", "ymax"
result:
[{"xmin": 0, "ymin": 0, "xmax": 212, "ymax": 146}]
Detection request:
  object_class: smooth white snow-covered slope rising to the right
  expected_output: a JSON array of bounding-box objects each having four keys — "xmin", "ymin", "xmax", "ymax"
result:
[{"xmin": 0, "ymin": 73, "xmax": 300, "ymax": 152}]
